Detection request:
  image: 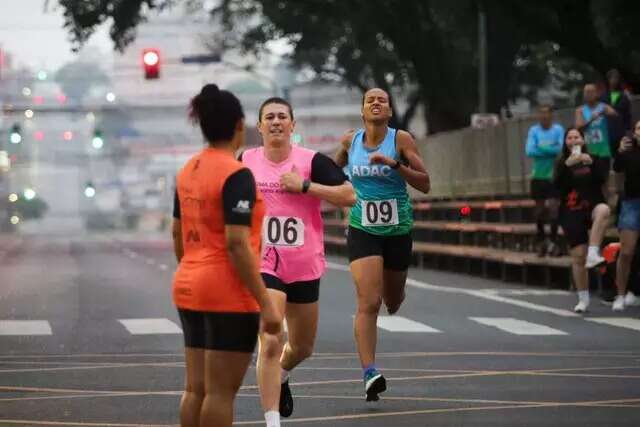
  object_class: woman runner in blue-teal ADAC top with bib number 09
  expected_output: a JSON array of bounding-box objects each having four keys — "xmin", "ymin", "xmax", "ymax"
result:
[{"xmin": 336, "ymin": 88, "xmax": 430, "ymax": 401}]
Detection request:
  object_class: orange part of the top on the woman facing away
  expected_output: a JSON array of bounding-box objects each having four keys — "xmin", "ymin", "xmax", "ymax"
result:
[{"xmin": 173, "ymin": 148, "xmax": 264, "ymax": 312}]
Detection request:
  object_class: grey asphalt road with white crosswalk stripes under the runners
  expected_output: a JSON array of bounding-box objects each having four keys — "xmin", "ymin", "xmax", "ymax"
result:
[{"xmin": 0, "ymin": 233, "xmax": 640, "ymax": 427}]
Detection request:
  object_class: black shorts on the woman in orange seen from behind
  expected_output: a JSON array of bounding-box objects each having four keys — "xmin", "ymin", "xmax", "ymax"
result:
[{"xmin": 178, "ymin": 308, "xmax": 260, "ymax": 353}]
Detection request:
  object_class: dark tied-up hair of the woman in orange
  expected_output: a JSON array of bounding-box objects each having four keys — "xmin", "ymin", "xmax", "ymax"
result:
[{"xmin": 189, "ymin": 83, "xmax": 244, "ymax": 143}]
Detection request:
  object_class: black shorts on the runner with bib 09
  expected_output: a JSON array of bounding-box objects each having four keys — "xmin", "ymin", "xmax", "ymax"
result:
[{"xmin": 347, "ymin": 226, "xmax": 413, "ymax": 271}]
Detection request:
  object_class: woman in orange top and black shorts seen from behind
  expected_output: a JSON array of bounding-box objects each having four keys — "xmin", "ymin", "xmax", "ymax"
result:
[{"xmin": 173, "ymin": 84, "xmax": 282, "ymax": 427}]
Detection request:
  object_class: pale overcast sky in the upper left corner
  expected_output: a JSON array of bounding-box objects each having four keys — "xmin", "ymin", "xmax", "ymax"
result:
[{"xmin": 0, "ymin": 0, "xmax": 112, "ymax": 71}]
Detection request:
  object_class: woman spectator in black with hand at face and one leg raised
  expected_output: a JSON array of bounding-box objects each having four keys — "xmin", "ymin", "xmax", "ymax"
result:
[{"xmin": 554, "ymin": 128, "xmax": 610, "ymax": 313}]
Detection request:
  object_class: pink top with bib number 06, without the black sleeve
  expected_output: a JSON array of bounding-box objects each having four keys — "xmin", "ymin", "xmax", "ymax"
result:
[{"xmin": 242, "ymin": 145, "xmax": 325, "ymax": 283}]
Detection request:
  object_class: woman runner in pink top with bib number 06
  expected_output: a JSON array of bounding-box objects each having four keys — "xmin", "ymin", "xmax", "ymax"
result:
[{"xmin": 241, "ymin": 98, "xmax": 355, "ymax": 427}]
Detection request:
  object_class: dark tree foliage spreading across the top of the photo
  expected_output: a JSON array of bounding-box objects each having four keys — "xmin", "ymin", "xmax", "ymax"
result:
[{"xmin": 60, "ymin": 0, "xmax": 640, "ymax": 132}]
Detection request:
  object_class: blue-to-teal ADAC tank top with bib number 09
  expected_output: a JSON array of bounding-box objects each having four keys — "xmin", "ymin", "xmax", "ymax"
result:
[{"xmin": 347, "ymin": 128, "xmax": 413, "ymax": 236}]
